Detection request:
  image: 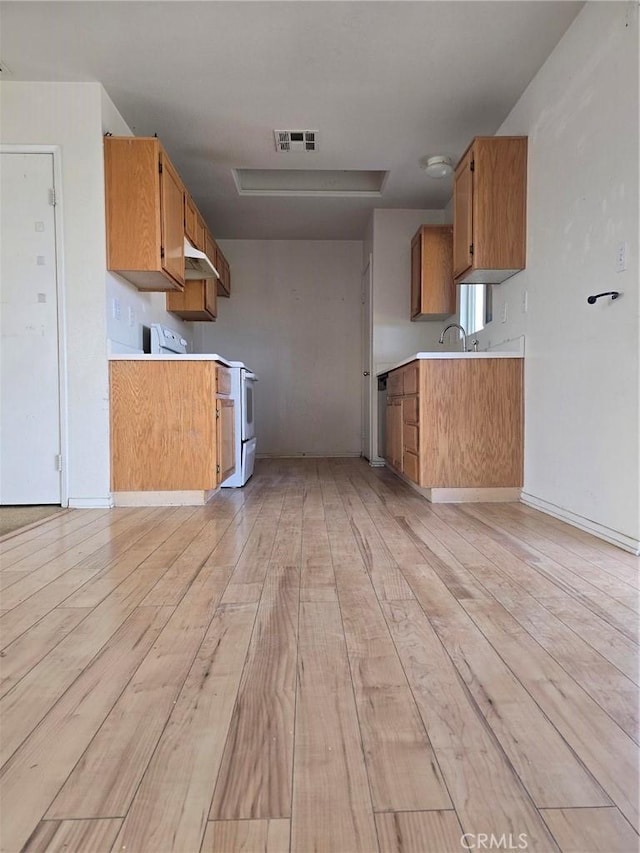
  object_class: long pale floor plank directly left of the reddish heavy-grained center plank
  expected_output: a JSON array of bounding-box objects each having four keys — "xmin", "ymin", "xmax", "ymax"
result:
[{"xmin": 116, "ymin": 604, "xmax": 258, "ymax": 853}]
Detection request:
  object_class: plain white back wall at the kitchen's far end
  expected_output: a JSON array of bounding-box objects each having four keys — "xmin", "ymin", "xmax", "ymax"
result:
[{"xmin": 195, "ymin": 240, "xmax": 362, "ymax": 456}]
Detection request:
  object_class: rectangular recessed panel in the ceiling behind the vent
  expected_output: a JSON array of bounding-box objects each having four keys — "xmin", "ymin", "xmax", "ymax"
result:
[{"xmin": 233, "ymin": 169, "xmax": 387, "ymax": 197}]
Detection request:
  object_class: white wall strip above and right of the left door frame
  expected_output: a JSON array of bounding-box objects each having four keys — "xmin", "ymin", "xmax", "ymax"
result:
[{"xmin": 0, "ymin": 82, "xmax": 109, "ymax": 506}]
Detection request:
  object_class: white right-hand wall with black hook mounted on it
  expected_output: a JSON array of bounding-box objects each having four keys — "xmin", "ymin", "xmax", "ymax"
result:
[{"xmin": 468, "ymin": 3, "xmax": 640, "ymax": 548}]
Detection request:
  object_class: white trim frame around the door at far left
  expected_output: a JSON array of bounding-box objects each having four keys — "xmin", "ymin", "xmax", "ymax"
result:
[{"xmin": 0, "ymin": 143, "xmax": 69, "ymax": 507}]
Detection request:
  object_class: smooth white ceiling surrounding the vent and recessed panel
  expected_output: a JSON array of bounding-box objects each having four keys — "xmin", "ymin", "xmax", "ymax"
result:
[{"xmin": 0, "ymin": 0, "xmax": 582, "ymax": 240}]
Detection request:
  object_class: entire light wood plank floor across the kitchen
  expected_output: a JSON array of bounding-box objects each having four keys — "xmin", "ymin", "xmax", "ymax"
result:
[{"xmin": 0, "ymin": 459, "xmax": 640, "ymax": 853}]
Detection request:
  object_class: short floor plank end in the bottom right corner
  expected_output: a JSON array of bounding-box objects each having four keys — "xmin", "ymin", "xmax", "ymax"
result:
[{"xmin": 541, "ymin": 808, "xmax": 639, "ymax": 853}]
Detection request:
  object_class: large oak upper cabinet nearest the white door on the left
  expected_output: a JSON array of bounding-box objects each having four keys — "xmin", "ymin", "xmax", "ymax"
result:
[{"xmin": 104, "ymin": 136, "xmax": 185, "ymax": 291}]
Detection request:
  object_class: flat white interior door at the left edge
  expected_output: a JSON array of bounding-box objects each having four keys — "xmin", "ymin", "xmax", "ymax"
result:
[{"xmin": 0, "ymin": 152, "xmax": 61, "ymax": 505}]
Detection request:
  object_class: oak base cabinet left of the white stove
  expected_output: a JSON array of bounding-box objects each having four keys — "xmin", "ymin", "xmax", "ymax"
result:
[{"xmin": 110, "ymin": 359, "xmax": 234, "ymax": 493}]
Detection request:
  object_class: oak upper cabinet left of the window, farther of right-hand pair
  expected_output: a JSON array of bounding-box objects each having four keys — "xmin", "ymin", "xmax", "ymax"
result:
[{"xmin": 411, "ymin": 225, "xmax": 456, "ymax": 320}]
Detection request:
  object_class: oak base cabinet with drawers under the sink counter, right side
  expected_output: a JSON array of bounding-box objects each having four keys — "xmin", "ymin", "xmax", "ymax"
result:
[{"xmin": 386, "ymin": 358, "xmax": 523, "ymax": 489}]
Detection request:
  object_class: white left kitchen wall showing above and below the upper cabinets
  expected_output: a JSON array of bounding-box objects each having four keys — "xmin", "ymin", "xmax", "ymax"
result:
[{"xmin": 101, "ymin": 89, "xmax": 193, "ymax": 352}]
